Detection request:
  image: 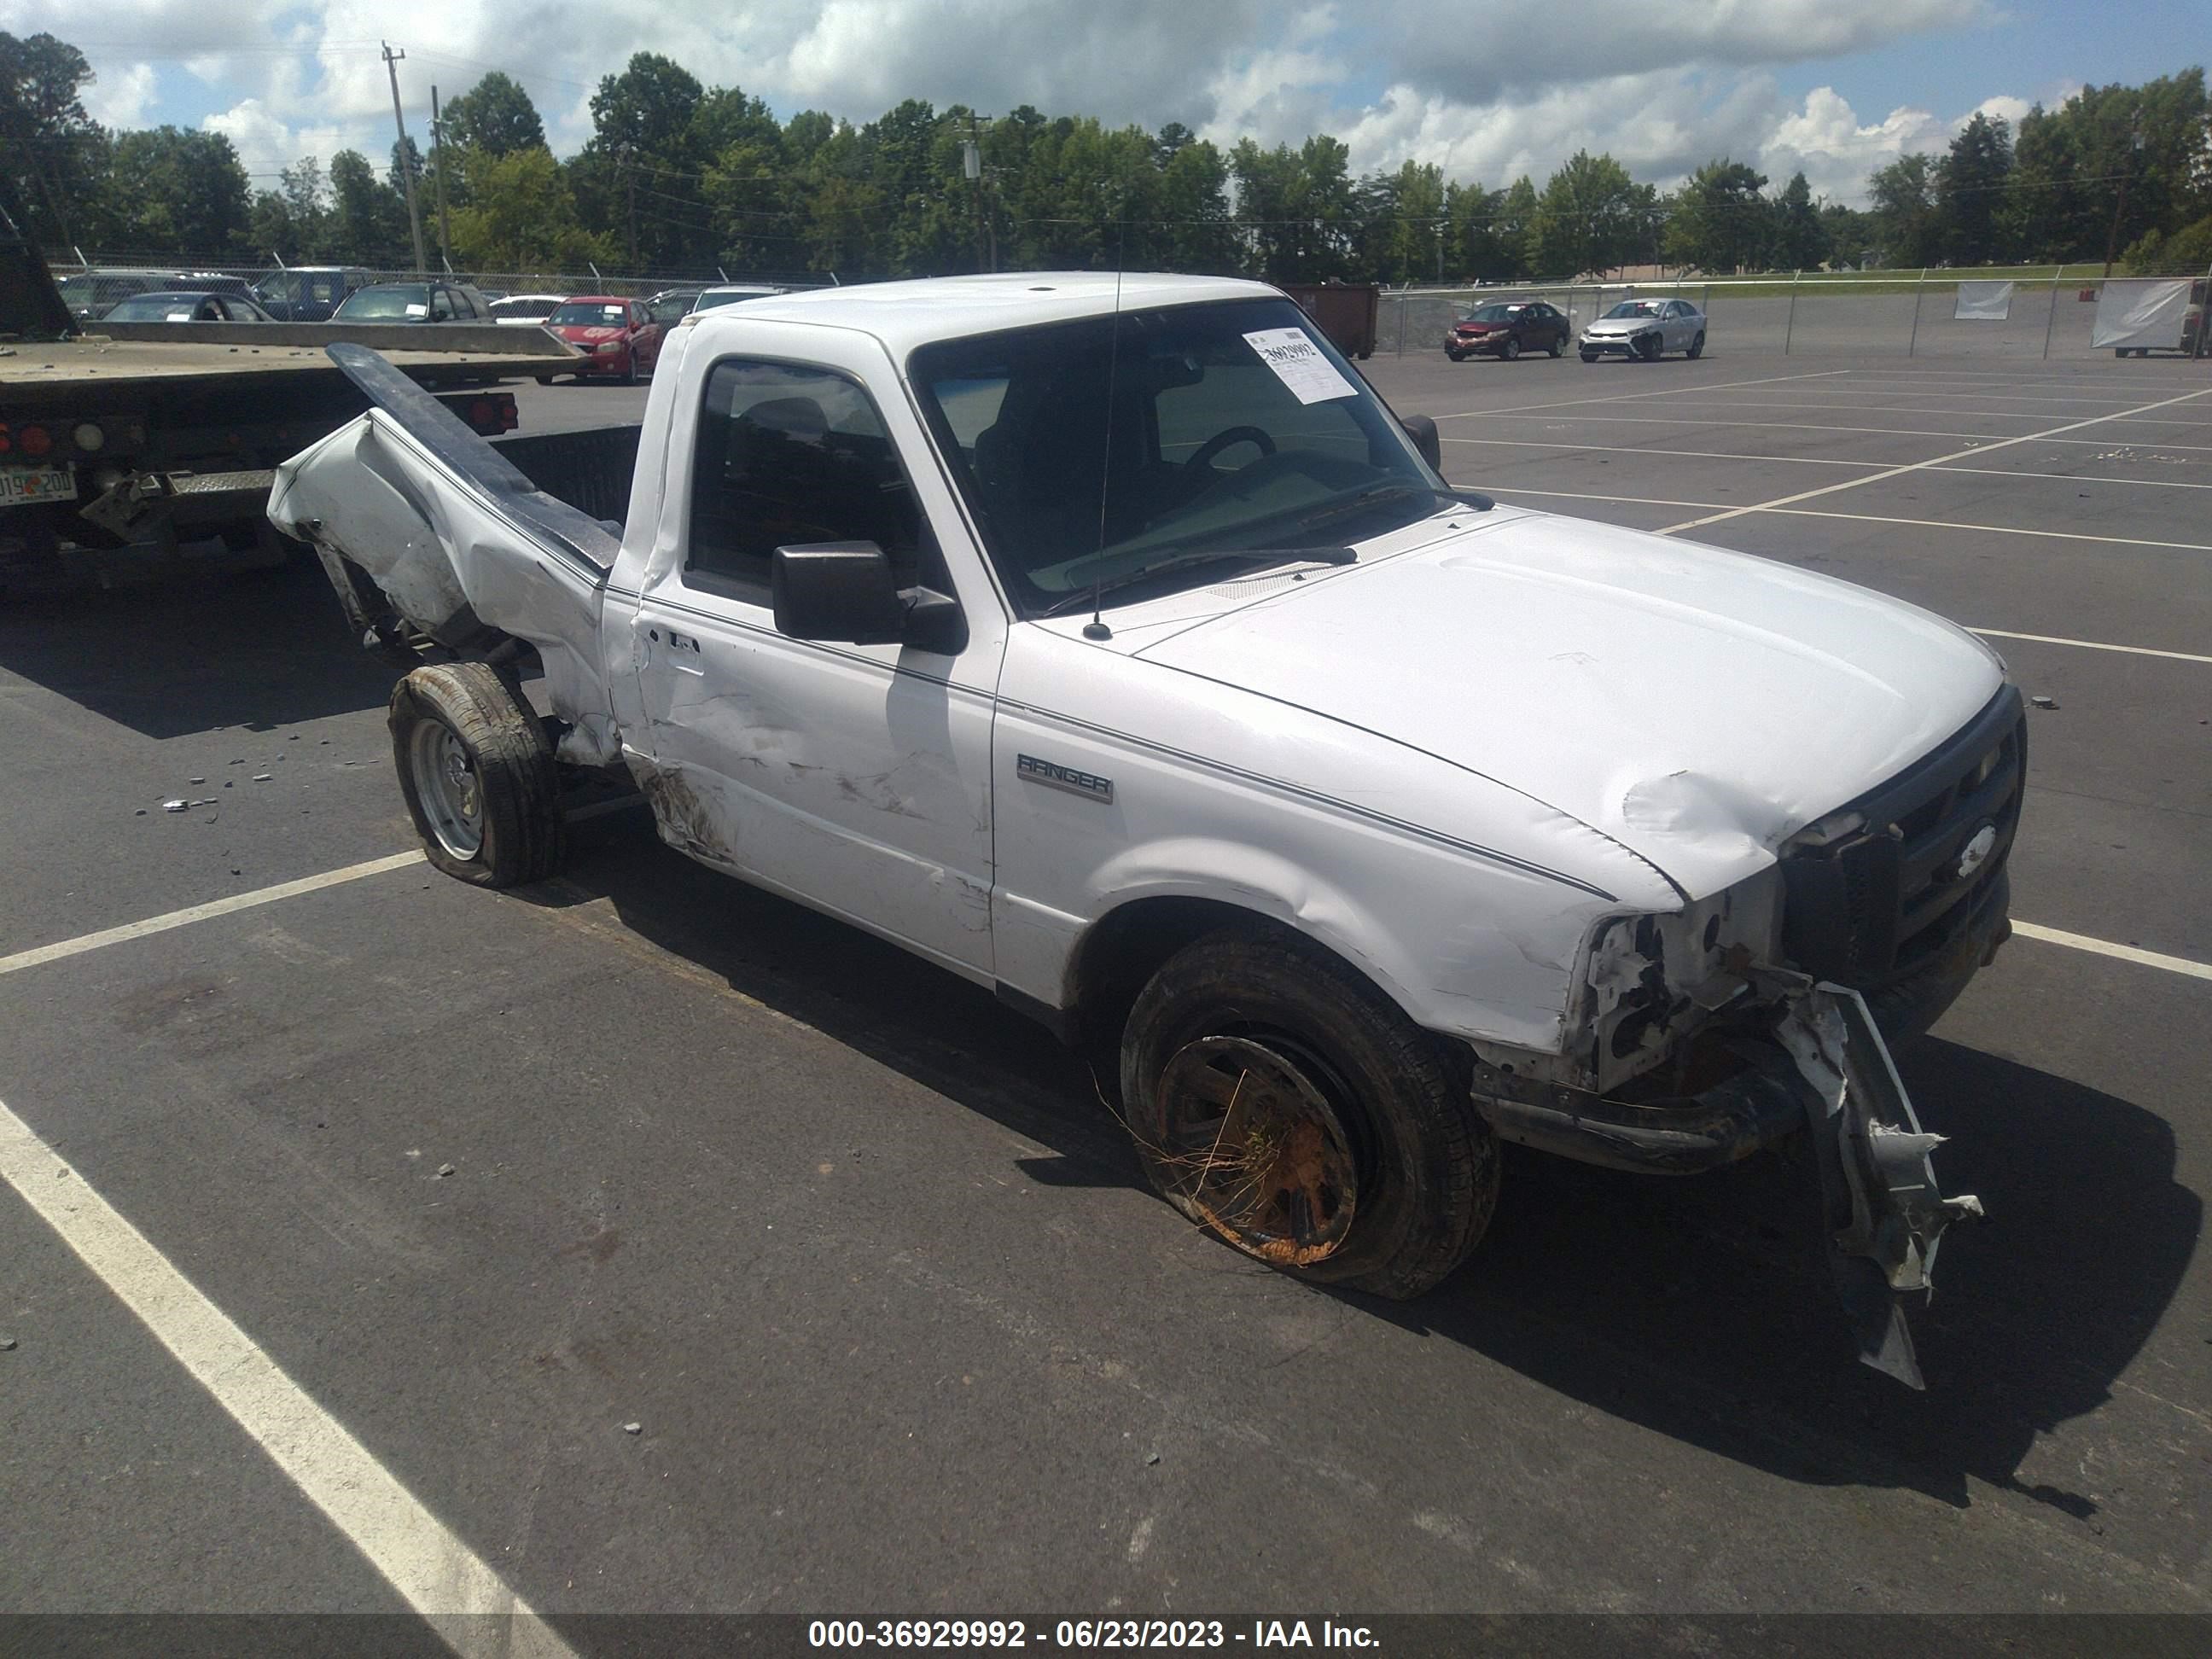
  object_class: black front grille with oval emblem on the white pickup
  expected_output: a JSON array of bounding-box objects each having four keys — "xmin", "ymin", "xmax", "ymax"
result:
[{"xmin": 1783, "ymin": 686, "xmax": 2029, "ymax": 991}]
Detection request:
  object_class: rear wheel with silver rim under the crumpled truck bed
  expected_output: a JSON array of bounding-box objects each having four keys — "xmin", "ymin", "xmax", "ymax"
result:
[{"xmin": 387, "ymin": 661, "xmax": 568, "ymax": 887}]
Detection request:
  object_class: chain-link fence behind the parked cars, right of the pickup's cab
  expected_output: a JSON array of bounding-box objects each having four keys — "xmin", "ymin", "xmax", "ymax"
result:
[{"xmin": 1376, "ymin": 265, "xmax": 2212, "ymax": 358}]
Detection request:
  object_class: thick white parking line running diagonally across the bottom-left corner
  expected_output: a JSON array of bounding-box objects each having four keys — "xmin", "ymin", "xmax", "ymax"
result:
[{"xmin": 0, "ymin": 1102, "xmax": 573, "ymax": 1659}]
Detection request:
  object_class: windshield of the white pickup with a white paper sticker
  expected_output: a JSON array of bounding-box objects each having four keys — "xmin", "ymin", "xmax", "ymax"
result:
[{"xmin": 909, "ymin": 299, "xmax": 1445, "ymax": 615}]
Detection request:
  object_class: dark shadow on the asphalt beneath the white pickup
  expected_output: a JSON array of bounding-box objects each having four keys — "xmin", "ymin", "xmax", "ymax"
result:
[{"xmin": 520, "ymin": 814, "xmax": 2203, "ymax": 1517}]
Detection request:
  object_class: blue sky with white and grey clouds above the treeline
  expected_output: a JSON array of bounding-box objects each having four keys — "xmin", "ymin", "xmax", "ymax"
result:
[{"xmin": 13, "ymin": 0, "xmax": 2205, "ymax": 201}]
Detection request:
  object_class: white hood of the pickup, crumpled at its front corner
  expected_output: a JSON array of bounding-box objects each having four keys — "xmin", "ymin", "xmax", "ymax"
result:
[{"xmin": 1137, "ymin": 509, "xmax": 2004, "ymax": 898}]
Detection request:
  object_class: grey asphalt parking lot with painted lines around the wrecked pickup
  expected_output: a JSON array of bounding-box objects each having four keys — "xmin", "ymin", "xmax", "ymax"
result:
[{"xmin": 0, "ymin": 341, "xmax": 2212, "ymax": 1652}]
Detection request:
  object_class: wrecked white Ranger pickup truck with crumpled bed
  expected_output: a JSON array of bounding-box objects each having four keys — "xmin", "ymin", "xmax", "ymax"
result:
[{"xmin": 270, "ymin": 274, "xmax": 2026, "ymax": 1385}]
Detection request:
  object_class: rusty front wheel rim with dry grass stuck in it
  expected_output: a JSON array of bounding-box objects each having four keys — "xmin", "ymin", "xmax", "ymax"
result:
[{"xmin": 1155, "ymin": 1038, "xmax": 1358, "ymax": 1267}]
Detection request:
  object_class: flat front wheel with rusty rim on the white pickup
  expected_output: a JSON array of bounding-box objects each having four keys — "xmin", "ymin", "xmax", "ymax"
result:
[{"xmin": 1121, "ymin": 929, "xmax": 1498, "ymax": 1299}]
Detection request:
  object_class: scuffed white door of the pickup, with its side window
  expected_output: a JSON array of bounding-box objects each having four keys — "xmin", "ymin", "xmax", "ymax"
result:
[{"xmin": 632, "ymin": 345, "xmax": 1006, "ymax": 978}]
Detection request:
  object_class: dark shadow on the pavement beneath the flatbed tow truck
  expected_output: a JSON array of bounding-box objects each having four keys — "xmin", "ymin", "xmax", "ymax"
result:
[{"xmin": 0, "ymin": 556, "xmax": 396, "ymax": 739}]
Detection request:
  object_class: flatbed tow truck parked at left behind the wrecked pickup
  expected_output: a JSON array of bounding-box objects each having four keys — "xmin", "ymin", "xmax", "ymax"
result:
[{"xmin": 0, "ymin": 201, "xmax": 578, "ymax": 595}]
